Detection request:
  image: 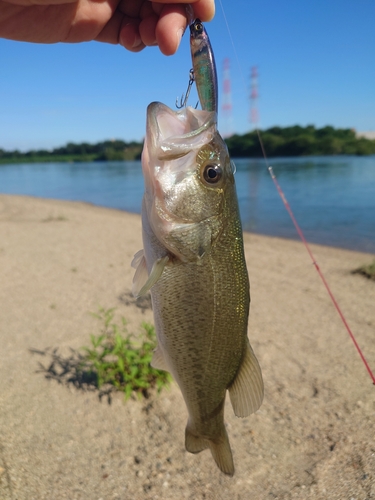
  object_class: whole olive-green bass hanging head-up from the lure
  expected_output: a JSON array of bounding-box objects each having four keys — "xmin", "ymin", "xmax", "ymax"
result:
[{"xmin": 132, "ymin": 102, "xmax": 263, "ymax": 476}]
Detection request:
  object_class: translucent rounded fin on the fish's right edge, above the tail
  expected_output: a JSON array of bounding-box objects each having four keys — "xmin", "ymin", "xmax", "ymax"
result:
[{"xmin": 228, "ymin": 341, "xmax": 264, "ymax": 417}]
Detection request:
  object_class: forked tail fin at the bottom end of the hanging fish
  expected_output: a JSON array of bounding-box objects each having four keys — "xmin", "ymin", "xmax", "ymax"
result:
[{"xmin": 185, "ymin": 424, "xmax": 234, "ymax": 476}]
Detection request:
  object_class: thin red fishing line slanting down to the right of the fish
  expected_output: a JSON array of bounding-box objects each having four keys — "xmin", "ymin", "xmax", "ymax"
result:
[{"xmin": 219, "ymin": 0, "xmax": 375, "ymax": 385}]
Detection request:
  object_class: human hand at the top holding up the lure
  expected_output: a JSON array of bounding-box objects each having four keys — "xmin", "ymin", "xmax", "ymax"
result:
[{"xmin": 0, "ymin": 0, "xmax": 215, "ymax": 55}]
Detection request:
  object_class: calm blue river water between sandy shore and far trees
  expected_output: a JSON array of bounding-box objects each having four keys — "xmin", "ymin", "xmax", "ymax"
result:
[{"xmin": 0, "ymin": 156, "xmax": 375, "ymax": 253}]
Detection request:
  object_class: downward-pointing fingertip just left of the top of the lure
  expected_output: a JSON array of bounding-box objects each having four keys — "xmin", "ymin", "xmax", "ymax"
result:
[{"xmin": 155, "ymin": 4, "xmax": 187, "ymax": 56}]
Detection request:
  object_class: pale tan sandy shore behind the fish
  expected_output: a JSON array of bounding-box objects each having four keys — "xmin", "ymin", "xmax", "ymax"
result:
[{"xmin": 0, "ymin": 192, "xmax": 375, "ymax": 500}]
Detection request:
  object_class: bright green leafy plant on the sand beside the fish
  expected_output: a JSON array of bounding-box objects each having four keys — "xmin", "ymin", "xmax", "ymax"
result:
[{"xmin": 80, "ymin": 308, "xmax": 171, "ymax": 400}]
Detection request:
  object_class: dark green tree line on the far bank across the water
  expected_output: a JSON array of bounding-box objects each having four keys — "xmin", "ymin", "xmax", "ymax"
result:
[{"xmin": 0, "ymin": 125, "xmax": 375, "ymax": 164}]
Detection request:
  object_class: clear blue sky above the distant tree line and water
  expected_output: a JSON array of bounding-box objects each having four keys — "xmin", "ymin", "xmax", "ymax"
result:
[{"xmin": 0, "ymin": 0, "xmax": 375, "ymax": 150}]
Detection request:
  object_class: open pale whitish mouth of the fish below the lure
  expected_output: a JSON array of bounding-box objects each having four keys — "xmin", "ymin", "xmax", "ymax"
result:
[{"xmin": 147, "ymin": 102, "xmax": 217, "ymax": 160}]
